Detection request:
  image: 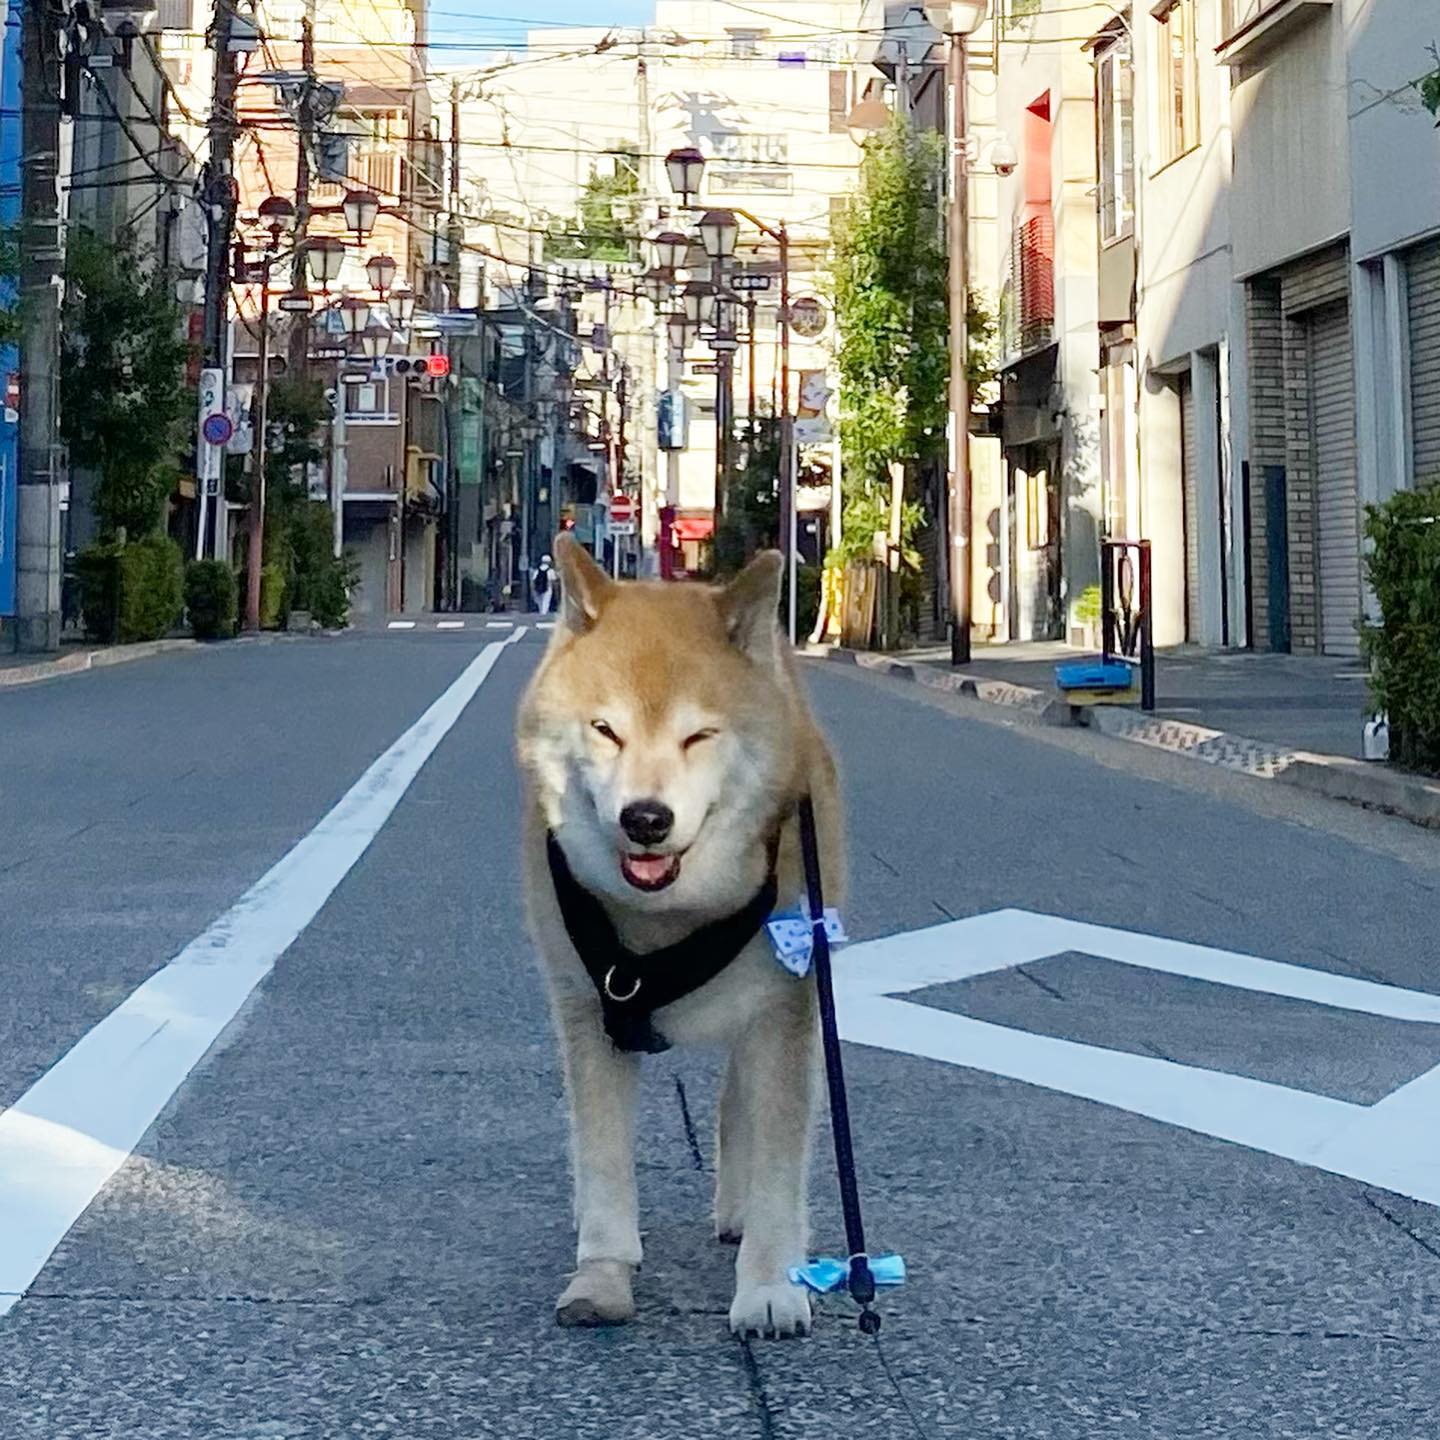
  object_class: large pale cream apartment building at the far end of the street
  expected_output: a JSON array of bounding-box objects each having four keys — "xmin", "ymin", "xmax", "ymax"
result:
[{"xmin": 442, "ymin": 0, "xmax": 860, "ymax": 578}]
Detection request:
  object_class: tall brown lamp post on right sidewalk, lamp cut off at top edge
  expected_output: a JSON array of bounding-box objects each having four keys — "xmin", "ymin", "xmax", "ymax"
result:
[{"xmin": 924, "ymin": 0, "xmax": 988, "ymax": 665}]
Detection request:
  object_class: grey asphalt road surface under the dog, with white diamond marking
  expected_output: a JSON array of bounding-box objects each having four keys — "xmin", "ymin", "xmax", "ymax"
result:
[{"xmin": 0, "ymin": 629, "xmax": 1440, "ymax": 1440}]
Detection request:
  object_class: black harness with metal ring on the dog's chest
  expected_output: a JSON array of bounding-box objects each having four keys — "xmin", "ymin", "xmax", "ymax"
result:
[{"xmin": 546, "ymin": 832, "xmax": 779, "ymax": 1056}]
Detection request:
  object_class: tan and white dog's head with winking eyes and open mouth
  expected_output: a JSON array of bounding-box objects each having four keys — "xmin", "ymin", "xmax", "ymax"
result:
[{"xmin": 520, "ymin": 539, "xmax": 796, "ymax": 913}]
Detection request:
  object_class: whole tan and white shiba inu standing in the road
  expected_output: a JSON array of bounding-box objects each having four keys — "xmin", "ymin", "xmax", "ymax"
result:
[{"xmin": 518, "ymin": 537, "xmax": 844, "ymax": 1336}]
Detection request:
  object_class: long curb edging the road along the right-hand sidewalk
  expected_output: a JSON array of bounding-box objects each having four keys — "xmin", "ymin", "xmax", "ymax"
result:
[{"xmin": 804, "ymin": 645, "xmax": 1440, "ymax": 829}]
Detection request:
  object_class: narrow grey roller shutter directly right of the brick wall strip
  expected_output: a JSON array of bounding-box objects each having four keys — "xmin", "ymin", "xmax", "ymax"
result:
[{"xmin": 1309, "ymin": 304, "xmax": 1359, "ymax": 655}]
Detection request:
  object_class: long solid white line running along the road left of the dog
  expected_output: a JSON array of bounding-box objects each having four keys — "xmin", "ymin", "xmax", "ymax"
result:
[{"xmin": 0, "ymin": 628, "xmax": 524, "ymax": 1315}]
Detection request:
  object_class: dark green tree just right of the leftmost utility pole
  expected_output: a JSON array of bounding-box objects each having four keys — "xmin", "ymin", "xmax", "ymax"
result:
[{"xmin": 60, "ymin": 229, "xmax": 194, "ymax": 536}]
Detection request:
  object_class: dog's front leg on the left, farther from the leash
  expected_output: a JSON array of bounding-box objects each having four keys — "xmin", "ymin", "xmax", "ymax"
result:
[{"xmin": 556, "ymin": 996, "xmax": 641, "ymax": 1325}]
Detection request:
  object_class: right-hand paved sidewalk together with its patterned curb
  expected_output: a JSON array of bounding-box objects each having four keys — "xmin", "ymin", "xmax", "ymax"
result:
[{"xmin": 812, "ymin": 641, "xmax": 1440, "ymax": 828}]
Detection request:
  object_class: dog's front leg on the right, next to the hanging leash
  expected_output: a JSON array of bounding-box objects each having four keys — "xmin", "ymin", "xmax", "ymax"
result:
[{"xmin": 730, "ymin": 985, "xmax": 816, "ymax": 1336}]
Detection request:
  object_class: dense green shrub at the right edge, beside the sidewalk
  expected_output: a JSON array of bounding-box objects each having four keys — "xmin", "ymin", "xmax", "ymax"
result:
[{"xmin": 1364, "ymin": 482, "xmax": 1440, "ymax": 773}]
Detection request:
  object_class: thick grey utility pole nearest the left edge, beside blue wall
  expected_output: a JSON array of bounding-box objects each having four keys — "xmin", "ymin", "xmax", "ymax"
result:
[{"xmin": 16, "ymin": 0, "xmax": 63, "ymax": 651}]
